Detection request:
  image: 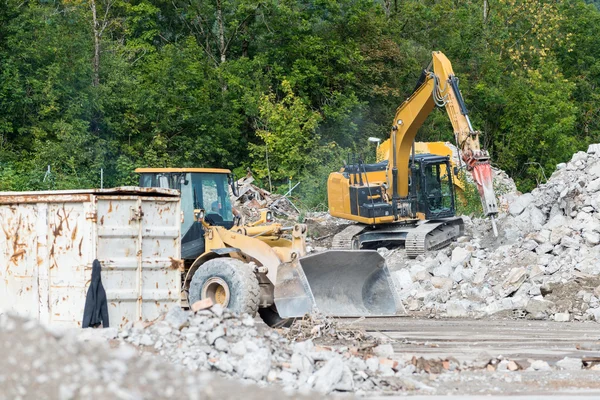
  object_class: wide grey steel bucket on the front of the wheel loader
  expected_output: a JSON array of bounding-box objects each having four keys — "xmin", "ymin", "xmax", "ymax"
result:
[{"xmin": 275, "ymin": 250, "xmax": 398, "ymax": 318}]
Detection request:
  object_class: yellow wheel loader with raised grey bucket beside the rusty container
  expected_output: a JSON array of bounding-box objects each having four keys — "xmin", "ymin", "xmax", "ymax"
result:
[{"xmin": 135, "ymin": 168, "xmax": 399, "ymax": 325}]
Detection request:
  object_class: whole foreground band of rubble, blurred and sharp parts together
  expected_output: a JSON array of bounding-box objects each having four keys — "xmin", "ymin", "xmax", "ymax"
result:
[{"xmin": 0, "ymin": 312, "xmax": 598, "ymax": 400}]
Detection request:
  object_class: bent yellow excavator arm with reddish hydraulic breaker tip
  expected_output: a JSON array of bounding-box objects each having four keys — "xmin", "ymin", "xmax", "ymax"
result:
[{"xmin": 387, "ymin": 51, "xmax": 498, "ymax": 235}]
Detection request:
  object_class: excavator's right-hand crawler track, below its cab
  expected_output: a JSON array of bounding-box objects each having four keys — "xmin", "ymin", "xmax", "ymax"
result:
[{"xmin": 404, "ymin": 218, "xmax": 464, "ymax": 258}]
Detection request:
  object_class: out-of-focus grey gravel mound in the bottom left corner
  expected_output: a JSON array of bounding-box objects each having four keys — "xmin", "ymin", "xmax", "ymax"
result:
[{"xmin": 0, "ymin": 314, "xmax": 308, "ymax": 400}]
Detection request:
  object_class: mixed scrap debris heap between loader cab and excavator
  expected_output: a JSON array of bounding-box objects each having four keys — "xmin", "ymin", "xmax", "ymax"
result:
[{"xmin": 231, "ymin": 171, "xmax": 298, "ymax": 222}]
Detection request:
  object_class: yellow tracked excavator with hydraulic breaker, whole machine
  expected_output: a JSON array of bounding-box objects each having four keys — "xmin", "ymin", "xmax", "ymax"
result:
[{"xmin": 327, "ymin": 51, "xmax": 498, "ymax": 258}]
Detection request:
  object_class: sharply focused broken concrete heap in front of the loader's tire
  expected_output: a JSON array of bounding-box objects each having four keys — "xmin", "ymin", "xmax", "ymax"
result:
[{"xmin": 118, "ymin": 305, "xmax": 434, "ymax": 393}]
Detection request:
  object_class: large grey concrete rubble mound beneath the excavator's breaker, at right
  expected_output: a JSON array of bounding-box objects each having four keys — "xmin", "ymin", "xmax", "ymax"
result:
[{"xmin": 390, "ymin": 145, "xmax": 600, "ymax": 321}]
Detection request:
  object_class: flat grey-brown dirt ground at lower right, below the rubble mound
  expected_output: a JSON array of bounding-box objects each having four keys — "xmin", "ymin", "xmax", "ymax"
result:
[{"xmin": 344, "ymin": 317, "xmax": 600, "ymax": 397}]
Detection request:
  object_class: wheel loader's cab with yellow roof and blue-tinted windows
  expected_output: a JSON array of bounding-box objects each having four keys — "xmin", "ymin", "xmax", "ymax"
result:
[{"xmin": 135, "ymin": 168, "xmax": 234, "ymax": 260}]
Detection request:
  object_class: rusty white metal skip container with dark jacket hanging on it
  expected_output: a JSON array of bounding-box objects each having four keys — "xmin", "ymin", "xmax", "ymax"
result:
[{"xmin": 0, "ymin": 187, "xmax": 182, "ymax": 327}]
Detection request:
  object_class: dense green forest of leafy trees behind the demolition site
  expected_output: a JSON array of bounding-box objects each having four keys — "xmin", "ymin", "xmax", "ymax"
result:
[{"xmin": 0, "ymin": 0, "xmax": 600, "ymax": 207}]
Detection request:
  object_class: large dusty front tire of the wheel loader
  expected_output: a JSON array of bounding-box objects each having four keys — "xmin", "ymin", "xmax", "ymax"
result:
[{"xmin": 188, "ymin": 257, "xmax": 260, "ymax": 316}]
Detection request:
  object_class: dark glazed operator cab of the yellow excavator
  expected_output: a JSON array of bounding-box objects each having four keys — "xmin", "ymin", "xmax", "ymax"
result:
[{"xmin": 409, "ymin": 154, "xmax": 456, "ymax": 220}]
